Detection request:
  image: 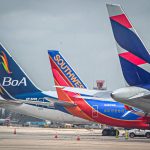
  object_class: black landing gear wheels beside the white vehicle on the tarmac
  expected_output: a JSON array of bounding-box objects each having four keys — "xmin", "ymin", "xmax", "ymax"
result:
[{"xmin": 102, "ymin": 128, "xmax": 119, "ymax": 136}]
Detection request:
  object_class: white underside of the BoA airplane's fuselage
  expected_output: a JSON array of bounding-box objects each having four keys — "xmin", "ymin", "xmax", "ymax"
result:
[{"xmin": 2, "ymin": 104, "xmax": 91, "ymax": 124}]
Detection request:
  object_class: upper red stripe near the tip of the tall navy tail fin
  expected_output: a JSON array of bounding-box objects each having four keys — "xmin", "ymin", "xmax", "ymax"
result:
[{"xmin": 110, "ymin": 14, "xmax": 132, "ymax": 28}]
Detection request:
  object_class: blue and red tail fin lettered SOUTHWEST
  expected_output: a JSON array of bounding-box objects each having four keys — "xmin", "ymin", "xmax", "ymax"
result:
[{"xmin": 48, "ymin": 50, "xmax": 86, "ymax": 88}]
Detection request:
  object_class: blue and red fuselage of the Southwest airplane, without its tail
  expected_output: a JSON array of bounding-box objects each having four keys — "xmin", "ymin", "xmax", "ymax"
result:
[{"xmin": 63, "ymin": 98, "xmax": 150, "ymax": 129}]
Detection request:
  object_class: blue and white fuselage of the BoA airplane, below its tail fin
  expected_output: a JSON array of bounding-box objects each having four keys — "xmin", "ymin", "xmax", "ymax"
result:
[{"xmin": 1, "ymin": 91, "xmax": 91, "ymax": 124}]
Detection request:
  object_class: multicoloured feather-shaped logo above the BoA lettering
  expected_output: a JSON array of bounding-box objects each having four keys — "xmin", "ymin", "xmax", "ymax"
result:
[{"xmin": 0, "ymin": 51, "xmax": 12, "ymax": 74}]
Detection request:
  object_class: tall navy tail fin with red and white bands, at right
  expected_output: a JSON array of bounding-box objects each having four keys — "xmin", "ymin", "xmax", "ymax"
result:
[{"xmin": 107, "ymin": 4, "xmax": 150, "ymax": 86}]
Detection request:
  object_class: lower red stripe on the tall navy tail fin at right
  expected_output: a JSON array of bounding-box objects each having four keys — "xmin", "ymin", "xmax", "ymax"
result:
[{"xmin": 119, "ymin": 52, "xmax": 146, "ymax": 65}]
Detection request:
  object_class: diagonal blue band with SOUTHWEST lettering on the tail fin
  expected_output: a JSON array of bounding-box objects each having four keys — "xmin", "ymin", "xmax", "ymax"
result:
[{"xmin": 51, "ymin": 53, "xmax": 85, "ymax": 88}]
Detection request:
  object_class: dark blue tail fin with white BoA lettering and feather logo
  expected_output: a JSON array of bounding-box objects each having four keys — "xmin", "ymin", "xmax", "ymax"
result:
[{"xmin": 0, "ymin": 44, "xmax": 40, "ymax": 97}]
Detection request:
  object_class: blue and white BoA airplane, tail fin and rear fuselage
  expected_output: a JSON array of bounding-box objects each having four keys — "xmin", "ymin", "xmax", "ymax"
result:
[{"xmin": 0, "ymin": 44, "xmax": 90, "ymax": 124}]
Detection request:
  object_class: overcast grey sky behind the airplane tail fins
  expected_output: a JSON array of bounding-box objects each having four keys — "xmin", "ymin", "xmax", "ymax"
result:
[{"xmin": 0, "ymin": 0, "xmax": 150, "ymax": 90}]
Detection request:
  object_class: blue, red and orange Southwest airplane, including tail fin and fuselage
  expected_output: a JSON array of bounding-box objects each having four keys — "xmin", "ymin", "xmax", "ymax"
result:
[{"xmin": 48, "ymin": 50, "xmax": 150, "ymax": 132}]
